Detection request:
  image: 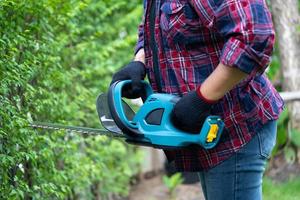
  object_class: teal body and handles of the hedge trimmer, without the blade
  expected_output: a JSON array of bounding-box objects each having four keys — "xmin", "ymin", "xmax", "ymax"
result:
[{"xmin": 97, "ymin": 80, "xmax": 224, "ymax": 149}]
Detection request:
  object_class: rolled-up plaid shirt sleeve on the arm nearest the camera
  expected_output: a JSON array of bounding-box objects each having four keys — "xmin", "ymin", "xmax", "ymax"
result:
[{"xmin": 190, "ymin": 0, "xmax": 275, "ymax": 74}]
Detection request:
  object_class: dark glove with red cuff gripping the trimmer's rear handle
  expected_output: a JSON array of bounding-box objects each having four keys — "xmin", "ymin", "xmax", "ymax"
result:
[{"xmin": 171, "ymin": 88, "xmax": 217, "ymax": 133}]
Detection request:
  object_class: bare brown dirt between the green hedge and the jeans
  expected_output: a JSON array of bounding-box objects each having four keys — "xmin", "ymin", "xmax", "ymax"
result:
[{"xmin": 128, "ymin": 174, "xmax": 204, "ymax": 200}]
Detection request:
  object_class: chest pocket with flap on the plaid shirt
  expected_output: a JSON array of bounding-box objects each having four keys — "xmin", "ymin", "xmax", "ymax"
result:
[{"xmin": 160, "ymin": 1, "xmax": 201, "ymax": 45}]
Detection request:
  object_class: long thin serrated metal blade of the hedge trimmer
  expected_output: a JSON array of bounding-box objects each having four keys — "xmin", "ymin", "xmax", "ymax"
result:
[{"xmin": 29, "ymin": 121, "xmax": 125, "ymax": 138}]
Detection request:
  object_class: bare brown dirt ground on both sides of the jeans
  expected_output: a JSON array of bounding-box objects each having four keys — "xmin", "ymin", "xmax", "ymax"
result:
[{"xmin": 126, "ymin": 155, "xmax": 300, "ymax": 200}]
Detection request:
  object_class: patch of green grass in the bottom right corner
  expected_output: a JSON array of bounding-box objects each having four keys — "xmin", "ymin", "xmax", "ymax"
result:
[{"xmin": 263, "ymin": 177, "xmax": 300, "ymax": 200}]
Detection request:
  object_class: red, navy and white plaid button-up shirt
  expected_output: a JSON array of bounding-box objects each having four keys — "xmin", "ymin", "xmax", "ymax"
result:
[{"xmin": 136, "ymin": 0, "xmax": 283, "ymax": 171}]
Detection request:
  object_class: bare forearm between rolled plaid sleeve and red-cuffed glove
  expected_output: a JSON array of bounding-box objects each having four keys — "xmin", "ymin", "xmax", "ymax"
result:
[{"xmin": 200, "ymin": 63, "xmax": 248, "ymax": 100}]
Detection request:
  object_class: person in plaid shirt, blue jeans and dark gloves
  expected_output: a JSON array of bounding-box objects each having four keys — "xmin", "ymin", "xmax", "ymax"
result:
[{"xmin": 112, "ymin": 0, "xmax": 284, "ymax": 200}]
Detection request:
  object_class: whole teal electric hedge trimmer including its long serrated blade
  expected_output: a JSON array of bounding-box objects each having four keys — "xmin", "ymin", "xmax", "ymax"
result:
[{"xmin": 30, "ymin": 80, "xmax": 224, "ymax": 149}]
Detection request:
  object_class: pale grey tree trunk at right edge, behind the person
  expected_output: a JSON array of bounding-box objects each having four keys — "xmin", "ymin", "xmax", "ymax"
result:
[{"xmin": 271, "ymin": 0, "xmax": 300, "ymax": 130}]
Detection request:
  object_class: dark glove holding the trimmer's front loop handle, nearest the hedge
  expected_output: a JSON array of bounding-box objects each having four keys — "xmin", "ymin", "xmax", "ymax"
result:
[{"xmin": 110, "ymin": 61, "xmax": 146, "ymax": 99}]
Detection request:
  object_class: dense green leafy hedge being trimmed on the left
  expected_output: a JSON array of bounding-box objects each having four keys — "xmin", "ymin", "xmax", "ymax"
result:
[{"xmin": 0, "ymin": 0, "xmax": 142, "ymax": 199}]
